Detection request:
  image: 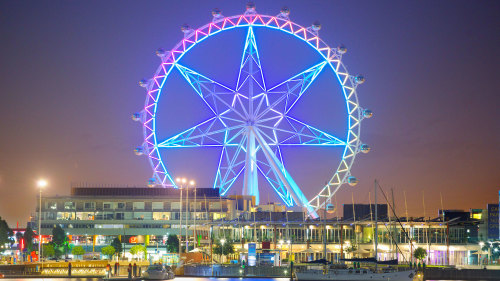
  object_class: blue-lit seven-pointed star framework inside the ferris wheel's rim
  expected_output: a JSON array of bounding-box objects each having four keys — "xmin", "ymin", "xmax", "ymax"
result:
[{"xmin": 158, "ymin": 27, "xmax": 345, "ymax": 212}]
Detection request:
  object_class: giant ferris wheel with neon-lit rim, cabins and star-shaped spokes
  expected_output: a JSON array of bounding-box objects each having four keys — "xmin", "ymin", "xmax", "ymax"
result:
[{"xmin": 132, "ymin": 3, "xmax": 373, "ymax": 218}]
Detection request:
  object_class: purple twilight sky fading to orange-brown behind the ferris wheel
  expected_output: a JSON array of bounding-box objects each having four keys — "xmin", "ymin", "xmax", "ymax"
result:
[{"xmin": 0, "ymin": 0, "xmax": 500, "ymax": 226}]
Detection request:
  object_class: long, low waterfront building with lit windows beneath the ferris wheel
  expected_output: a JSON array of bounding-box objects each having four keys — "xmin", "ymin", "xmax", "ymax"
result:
[{"xmin": 33, "ymin": 187, "xmax": 492, "ymax": 265}]
